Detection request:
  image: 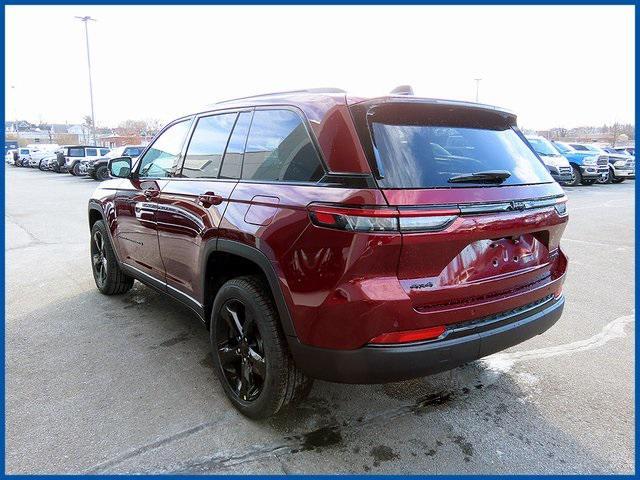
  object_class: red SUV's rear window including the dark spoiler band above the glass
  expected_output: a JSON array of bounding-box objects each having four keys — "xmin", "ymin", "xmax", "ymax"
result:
[{"xmin": 358, "ymin": 102, "xmax": 553, "ymax": 188}]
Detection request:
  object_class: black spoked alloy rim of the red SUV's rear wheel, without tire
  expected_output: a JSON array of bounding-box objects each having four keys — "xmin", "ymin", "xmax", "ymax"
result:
[{"xmin": 216, "ymin": 299, "xmax": 267, "ymax": 402}]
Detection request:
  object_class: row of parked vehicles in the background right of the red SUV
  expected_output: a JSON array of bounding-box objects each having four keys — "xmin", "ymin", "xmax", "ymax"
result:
[{"xmin": 526, "ymin": 135, "xmax": 636, "ymax": 186}]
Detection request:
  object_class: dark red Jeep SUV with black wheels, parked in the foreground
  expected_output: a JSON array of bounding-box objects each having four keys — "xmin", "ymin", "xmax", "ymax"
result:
[{"xmin": 89, "ymin": 89, "xmax": 567, "ymax": 418}]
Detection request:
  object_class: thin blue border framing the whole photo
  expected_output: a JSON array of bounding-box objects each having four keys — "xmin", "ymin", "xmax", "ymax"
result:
[{"xmin": 0, "ymin": 0, "xmax": 640, "ymax": 480}]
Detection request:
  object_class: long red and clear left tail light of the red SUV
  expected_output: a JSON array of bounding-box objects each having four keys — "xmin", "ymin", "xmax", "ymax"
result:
[{"xmin": 309, "ymin": 204, "xmax": 460, "ymax": 232}]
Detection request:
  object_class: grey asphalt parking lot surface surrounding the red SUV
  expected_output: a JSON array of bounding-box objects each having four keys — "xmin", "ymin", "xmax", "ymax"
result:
[{"xmin": 5, "ymin": 166, "xmax": 635, "ymax": 474}]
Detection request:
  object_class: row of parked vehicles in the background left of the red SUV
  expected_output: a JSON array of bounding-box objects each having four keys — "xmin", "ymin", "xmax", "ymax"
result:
[{"xmin": 6, "ymin": 144, "xmax": 144, "ymax": 181}]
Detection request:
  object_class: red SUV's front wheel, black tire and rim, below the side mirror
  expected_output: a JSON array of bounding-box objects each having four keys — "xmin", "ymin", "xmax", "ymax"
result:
[{"xmin": 90, "ymin": 220, "xmax": 133, "ymax": 295}]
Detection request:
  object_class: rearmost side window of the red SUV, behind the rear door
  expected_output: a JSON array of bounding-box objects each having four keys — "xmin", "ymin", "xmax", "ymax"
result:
[{"xmin": 242, "ymin": 110, "xmax": 323, "ymax": 182}]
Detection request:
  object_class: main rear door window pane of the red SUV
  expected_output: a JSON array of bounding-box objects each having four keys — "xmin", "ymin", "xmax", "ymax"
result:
[{"xmin": 182, "ymin": 113, "xmax": 237, "ymax": 178}]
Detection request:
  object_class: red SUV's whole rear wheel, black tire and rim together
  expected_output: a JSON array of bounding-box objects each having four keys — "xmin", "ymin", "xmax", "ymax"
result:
[{"xmin": 210, "ymin": 276, "xmax": 313, "ymax": 419}]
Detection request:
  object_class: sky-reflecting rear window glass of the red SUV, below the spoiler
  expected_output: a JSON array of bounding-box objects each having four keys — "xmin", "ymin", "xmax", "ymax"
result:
[{"xmin": 371, "ymin": 122, "xmax": 552, "ymax": 188}]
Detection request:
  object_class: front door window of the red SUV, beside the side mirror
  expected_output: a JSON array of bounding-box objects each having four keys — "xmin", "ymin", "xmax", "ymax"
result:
[{"xmin": 139, "ymin": 120, "xmax": 191, "ymax": 177}]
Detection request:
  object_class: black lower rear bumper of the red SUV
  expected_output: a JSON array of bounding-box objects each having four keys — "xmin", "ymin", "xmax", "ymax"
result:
[{"xmin": 290, "ymin": 296, "xmax": 564, "ymax": 383}]
